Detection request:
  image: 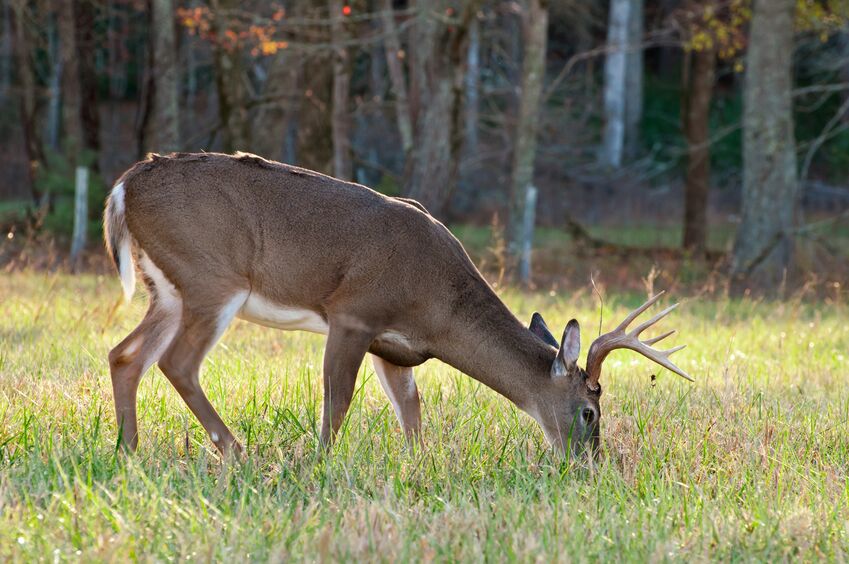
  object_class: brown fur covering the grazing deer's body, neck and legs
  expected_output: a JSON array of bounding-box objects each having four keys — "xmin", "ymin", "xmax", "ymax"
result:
[{"xmin": 107, "ymin": 153, "xmax": 599, "ymax": 458}]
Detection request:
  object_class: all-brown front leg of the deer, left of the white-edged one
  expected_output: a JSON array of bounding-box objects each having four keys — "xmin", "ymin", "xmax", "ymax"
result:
[{"xmin": 321, "ymin": 319, "xmax": 374, "ymax": 447}]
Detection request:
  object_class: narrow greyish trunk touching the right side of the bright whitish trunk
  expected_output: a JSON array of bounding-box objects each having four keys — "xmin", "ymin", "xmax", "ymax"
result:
[{"xmin": 625, "ymin": 0, "xmax": 643, "ymax": 159}]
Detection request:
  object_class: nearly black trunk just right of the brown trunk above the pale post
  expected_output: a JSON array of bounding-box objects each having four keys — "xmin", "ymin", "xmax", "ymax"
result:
[{"xmin": 74, "ymin": 0, "xmax": 100, "ymax": 159}]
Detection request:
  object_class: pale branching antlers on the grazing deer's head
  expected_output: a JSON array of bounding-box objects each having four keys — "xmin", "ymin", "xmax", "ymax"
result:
[{"xmin": 587, "ymin": 292, "xmax": 694, "ymax": 390}]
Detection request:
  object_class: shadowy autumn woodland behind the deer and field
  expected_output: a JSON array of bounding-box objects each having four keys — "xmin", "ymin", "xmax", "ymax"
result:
[{"xmin": 0, "ymin": 0, "xmax": 849, "ymax": 293}]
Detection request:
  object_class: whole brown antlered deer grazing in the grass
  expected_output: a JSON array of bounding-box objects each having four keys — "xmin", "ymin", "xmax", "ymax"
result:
[{"xmin": 104, "ymin": 153, "xmax": 689, "ymax": 454}]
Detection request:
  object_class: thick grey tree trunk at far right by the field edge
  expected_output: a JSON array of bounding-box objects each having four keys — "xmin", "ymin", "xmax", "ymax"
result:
[{"xmin": 731, "ymin": 0, "xmax": 799, "ymax": 291}]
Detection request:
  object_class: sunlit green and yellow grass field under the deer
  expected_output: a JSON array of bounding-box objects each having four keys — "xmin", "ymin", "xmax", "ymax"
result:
[{"xmin": 0, "ymin": 273, "xmax": 849, "ymax": 561}]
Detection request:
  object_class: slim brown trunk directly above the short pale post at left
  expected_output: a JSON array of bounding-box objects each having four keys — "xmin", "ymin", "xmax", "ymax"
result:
[{"xmin": 56, "ymin": 0, "xmax": 83, "ymax": 164}]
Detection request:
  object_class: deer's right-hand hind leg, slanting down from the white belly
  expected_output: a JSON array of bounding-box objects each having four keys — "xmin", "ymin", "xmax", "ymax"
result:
[{"xmin": 159, "ymin": 292, "xmax": 247, "ymax": 456}]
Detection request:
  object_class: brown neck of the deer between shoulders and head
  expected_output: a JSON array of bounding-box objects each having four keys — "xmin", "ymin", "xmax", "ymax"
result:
[{"xmin": 433, "ymin": 280, "xmax": 557, "ymax": 413}]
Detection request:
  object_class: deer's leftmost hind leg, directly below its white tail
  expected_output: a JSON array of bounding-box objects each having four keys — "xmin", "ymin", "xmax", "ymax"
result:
[{"xmin": 109, "ymin": 296, "xmax": 180, "ymax": 451}]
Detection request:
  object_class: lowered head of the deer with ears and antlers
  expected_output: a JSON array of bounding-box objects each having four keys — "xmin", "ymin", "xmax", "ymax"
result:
[{"xmin": 529, "ymin": 292, "xmax": 693, "ymax": 455}]
